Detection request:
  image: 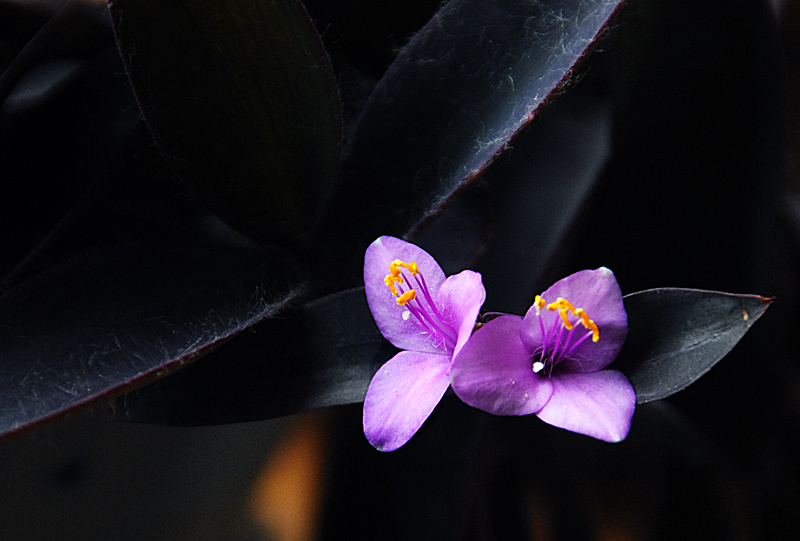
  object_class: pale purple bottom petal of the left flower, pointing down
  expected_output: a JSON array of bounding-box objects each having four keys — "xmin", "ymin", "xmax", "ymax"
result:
[{"xmin": 364, "ymin": 351, "xmax": 450, "ymax": 451}]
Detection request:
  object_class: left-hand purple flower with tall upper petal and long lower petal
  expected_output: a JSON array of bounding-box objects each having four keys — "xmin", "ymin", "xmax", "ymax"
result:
[{"xmin": 364, "ymin": 237, "xmax": 486, "ymax": 451}]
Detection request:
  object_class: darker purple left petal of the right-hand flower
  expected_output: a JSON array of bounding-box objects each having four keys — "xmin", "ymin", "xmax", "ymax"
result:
[{"xmin": 450, "ymin": 316, "xmax": 553, "ymax": 415}]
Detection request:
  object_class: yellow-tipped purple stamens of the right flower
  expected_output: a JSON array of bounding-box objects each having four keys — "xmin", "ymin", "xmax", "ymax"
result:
[{"xmin": 532, "ymin": 295, "xmax": 600, "ymax": 377}]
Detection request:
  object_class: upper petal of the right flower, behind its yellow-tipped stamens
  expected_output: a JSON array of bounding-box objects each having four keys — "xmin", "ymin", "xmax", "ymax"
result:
[{"xmin": 521, "ymin": 267, "xmax": 628, "ymax": 372}]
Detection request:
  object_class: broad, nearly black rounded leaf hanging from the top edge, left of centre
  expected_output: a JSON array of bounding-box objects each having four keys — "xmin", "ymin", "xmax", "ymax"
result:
[{"xmin": 109, "ymin": 0, "xmax": 341, "ymax": 238}]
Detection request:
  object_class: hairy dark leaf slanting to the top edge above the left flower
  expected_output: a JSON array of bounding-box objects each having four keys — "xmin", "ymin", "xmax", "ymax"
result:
[{"xmin": 324, "ymin": 0, "xmax": 620, "ymax": 251}]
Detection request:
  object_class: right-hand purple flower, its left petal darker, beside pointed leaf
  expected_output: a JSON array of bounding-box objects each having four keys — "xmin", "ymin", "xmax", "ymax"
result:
[{"xmin": 450, "ymin": 267, "xmax": 636, "ymax": 442}]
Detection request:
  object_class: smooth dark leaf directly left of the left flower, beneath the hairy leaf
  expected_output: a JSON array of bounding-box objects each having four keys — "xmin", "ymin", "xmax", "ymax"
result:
[{"xmin": 114, "ymin": 287, "xmax": 397, "ymax": 425}]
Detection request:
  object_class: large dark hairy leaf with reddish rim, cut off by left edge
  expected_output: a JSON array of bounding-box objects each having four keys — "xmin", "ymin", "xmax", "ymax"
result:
[{"xmin": 0, "ymin": 240, "xmax": 296, "ymax": 436}]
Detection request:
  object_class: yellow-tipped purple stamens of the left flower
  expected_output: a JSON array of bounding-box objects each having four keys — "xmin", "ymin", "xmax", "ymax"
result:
[{"xmin": 383, "ymin": 259, "xmax": 458, "ymax": 352}]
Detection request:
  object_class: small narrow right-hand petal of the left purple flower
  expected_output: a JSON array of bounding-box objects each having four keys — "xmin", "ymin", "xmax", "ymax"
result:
[{"xmin": 438, "ymin": 270, "xmax": 486, "ymax": 356}]
